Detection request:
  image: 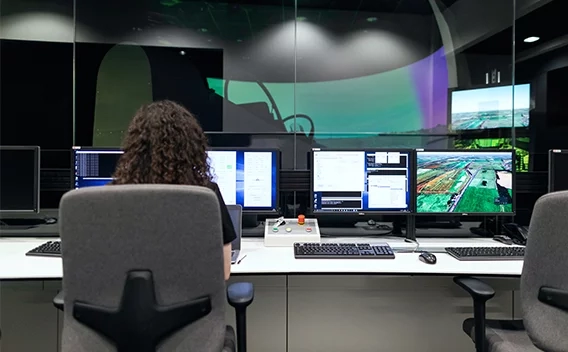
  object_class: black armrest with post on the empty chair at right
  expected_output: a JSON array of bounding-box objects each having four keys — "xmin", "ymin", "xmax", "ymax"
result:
[{"xmin": 454, "ymin": 276, "xmax": 495, "ymax": 352}]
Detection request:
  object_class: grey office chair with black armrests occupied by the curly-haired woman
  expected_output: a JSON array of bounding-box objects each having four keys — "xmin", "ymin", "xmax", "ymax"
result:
[{"xmin": 54, "ymin": 185, "xmax": 254, "ymax": 352}]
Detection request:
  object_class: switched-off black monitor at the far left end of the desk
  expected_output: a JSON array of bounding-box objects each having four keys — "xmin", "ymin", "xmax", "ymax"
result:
[{"xmin": 0, "ymin": 146, "xmax": 40, "ymax": 213}]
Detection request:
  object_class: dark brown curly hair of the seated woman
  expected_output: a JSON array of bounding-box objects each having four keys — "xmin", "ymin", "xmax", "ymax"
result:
[{"xmin": 112, "ymin": 100, "xmax": 211, "ymax": 186}]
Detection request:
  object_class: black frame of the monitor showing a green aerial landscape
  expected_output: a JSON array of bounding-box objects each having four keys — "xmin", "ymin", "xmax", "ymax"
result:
[{"xmin": 414, "ymin": 149, "xmax": 517, "ymax": 217}]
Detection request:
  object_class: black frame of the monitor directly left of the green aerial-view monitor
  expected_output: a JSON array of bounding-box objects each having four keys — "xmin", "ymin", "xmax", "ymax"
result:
[{"xmin": 308, "ymin": 148, "xmax": 416, "ymax": 217}]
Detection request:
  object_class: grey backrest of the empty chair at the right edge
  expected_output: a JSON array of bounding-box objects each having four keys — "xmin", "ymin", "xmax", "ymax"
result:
[{"xmin": 521, "ymin": 192, "xmax": 568, "ymax": 352}]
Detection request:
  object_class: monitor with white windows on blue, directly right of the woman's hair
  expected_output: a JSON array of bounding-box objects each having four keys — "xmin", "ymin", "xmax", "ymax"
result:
[{"xmin": 207, "ymin": 148, "xmax": 280, "ymax": 213}]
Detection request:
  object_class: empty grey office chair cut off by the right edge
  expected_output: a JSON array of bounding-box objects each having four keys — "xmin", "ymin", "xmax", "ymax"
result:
[{"xmin": 454, "ymin": 192, "xmax": 568, "ymax": 352}]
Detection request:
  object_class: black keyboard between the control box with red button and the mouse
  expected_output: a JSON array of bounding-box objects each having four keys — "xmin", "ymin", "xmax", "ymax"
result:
[{"xmin": 294, "ymin": 243, "xmax": 394, "ymax": 259}]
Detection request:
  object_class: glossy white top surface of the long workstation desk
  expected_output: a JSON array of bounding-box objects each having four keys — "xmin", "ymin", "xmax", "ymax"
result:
[{"xmin": 0, "ymin": 238, "xmax": 522, "ymax": 280}]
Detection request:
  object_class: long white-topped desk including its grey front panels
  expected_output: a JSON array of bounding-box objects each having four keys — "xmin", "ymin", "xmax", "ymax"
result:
[{"xmin": 0, "ymin": 237, "xmax": 522, "ymax": 352}]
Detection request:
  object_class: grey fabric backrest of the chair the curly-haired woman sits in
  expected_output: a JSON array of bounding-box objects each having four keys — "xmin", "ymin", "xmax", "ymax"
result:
[{"xmin": 60, "ymin": 185, "xmax": 226, "ymax": 352}]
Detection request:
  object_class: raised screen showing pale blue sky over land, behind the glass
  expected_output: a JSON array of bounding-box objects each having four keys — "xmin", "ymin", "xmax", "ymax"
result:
[{"xmin": 451, "ymin": 84, "xmax": 531, "ymax": 131}]
